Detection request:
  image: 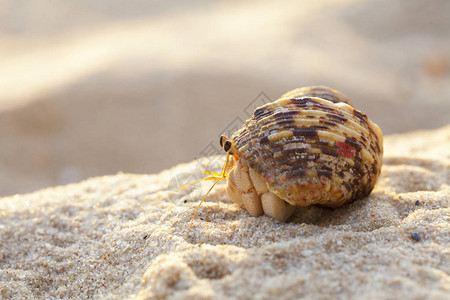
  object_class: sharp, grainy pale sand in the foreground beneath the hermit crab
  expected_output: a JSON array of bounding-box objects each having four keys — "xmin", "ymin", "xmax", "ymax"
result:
[{"xmin": 0, "ymin": 127, "xmax": 450, "ymax": 299}]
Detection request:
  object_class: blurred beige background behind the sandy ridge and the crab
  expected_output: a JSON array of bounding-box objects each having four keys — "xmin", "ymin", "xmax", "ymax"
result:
[{"xmin": 0, "ymin": 0, "xmax": 450, "ymax": 196}]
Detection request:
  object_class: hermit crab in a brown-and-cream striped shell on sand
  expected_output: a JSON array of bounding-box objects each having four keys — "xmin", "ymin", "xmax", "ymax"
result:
[{"xmin": 169, "ymin": 86, "xmax": 383, "ymax": 229}]
